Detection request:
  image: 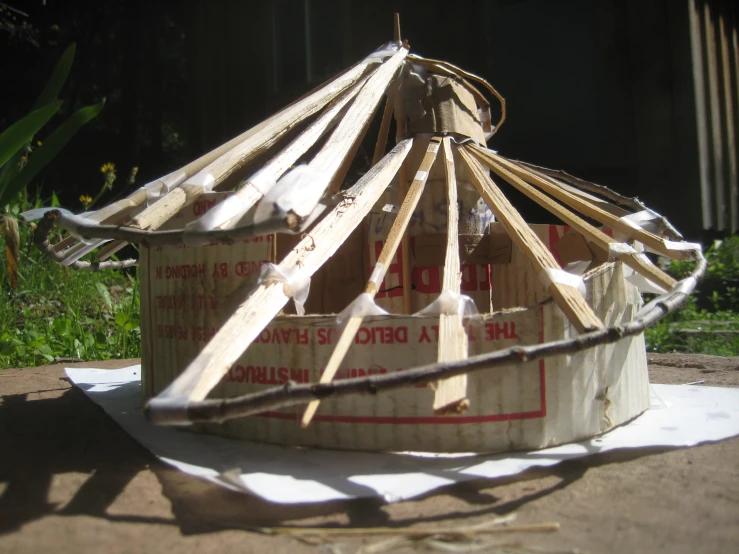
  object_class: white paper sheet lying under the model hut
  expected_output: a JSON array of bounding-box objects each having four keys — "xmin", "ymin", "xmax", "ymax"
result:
[{"xmin": 67, "ymin": 366, "xmax": 739, "ymax": 504}]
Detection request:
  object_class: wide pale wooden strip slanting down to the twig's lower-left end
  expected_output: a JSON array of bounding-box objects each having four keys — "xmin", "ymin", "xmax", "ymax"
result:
[{"xmin": 150, "ymin": 139, "xmax": 413, "ymax": 410}]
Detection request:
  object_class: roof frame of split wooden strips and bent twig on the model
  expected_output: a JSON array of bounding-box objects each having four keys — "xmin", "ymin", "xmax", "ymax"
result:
[{"xmin": 26, "ymin": 31, "xmax": 705, "ymax": 424}]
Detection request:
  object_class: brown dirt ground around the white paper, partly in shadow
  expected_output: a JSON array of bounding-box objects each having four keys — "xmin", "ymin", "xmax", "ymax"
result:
[{"xmin": 0, "ymin": 355, "xmax": 739, "ymax": 554}]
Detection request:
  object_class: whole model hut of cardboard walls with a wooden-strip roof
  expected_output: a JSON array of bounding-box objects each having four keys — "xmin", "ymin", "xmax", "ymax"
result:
[{"xmin": 31, "ymin": 21, "xmax": 705, "ymax": 452}]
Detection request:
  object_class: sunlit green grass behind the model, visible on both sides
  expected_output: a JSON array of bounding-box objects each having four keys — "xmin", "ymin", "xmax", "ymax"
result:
[{"xmin": 0, "ymin": 196, "xmax": 739, "ymax": 368}]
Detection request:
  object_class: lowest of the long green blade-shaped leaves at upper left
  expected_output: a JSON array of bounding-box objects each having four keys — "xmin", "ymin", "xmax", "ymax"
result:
[{"xmin": 0, "ymin": 99, "xmax": 105, "ymax": 206}]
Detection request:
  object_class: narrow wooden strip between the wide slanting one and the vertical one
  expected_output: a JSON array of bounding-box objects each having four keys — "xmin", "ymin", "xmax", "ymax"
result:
[{"xmin": 301, "ymin": 137, "xmax": 440, "ymax": 427}]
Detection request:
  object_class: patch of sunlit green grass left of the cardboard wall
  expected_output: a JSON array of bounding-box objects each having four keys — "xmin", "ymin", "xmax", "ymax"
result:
[{"xmin": 0, "ymin": 216, "xmax": 141, "ymax": 368}]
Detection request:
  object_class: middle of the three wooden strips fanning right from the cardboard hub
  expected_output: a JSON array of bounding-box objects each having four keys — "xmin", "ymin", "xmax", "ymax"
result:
[{"xmin": 470, "ymin": 149, "xmax": 677, "ymax": 290}]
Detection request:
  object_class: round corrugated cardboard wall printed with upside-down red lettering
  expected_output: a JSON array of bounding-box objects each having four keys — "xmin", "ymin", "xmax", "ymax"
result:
[{"xmin": 141, "ymin": 193, "xmax": 649, "ymax": 452}]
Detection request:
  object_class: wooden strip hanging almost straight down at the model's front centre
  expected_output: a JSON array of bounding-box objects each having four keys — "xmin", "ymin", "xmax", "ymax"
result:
[{"xmin": 434, "ymin": 137, "xmax": 470, "ymax": 415}]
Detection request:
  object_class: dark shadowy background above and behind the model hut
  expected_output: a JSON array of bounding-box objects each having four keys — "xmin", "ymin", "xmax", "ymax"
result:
[{"xmin": 0, "ymin": 0, "xmax": 736, "ymax": 238}]
